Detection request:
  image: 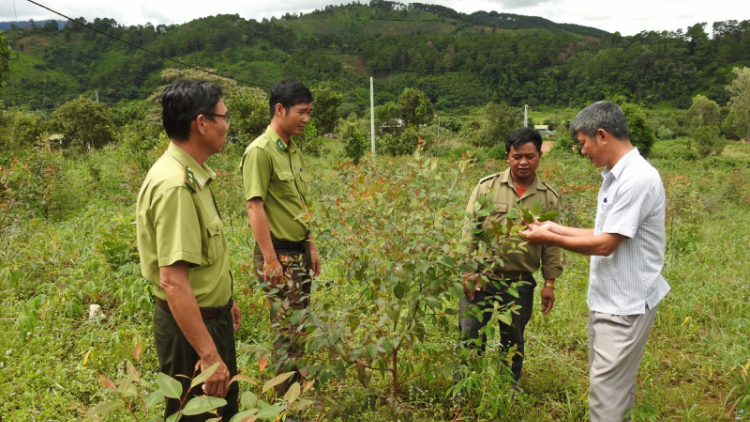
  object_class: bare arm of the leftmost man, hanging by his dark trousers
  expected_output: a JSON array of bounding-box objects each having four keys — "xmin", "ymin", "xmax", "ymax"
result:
[{"xmin": 164, "ymin": 261, "xmax": 229, "ymax": 397}]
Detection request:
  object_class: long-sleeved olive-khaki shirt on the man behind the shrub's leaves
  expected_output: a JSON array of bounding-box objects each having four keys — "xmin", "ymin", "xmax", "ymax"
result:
[{"xmin": 463, "ymin": 169, "xmax": 562, "ymax": 279}]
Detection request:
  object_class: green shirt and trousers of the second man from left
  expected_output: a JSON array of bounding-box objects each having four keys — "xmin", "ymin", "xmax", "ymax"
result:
[{"xmin": 240, "ymin": 126, "xmax": 312, "ymax": 392}]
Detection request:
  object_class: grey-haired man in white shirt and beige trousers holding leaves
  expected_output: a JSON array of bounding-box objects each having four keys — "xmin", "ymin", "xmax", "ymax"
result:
[{"xmin": 522, "ymin": 101, "xmax": 669, "ymax": 422}]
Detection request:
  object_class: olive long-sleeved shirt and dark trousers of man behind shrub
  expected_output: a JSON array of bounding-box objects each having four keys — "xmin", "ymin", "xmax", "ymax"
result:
[{"xmin": 459, "ymin": 169, "xmax": 562, "ymax": 380}]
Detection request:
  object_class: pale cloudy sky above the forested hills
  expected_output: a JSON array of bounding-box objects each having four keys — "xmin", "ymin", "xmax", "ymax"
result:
[{"xmin": 0, "ymin": 0, "xmax": 750, "ymax": 35}]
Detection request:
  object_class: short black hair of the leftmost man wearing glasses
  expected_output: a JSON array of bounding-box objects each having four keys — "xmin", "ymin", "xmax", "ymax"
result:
[{"xmin": 161, "ymin": 80, "xmax": 221, "ymax": 141}]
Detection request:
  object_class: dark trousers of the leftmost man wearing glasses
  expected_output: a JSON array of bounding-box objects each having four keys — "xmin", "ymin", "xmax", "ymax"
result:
[{"xmin": 154, "ymin": 306, "xmax": 239, "ymax": 422}]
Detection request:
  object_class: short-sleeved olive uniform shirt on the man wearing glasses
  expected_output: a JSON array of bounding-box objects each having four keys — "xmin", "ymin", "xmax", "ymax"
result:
[{"xmin": 136, "ymin": 142, "xmax": 232, "ymax": 307}]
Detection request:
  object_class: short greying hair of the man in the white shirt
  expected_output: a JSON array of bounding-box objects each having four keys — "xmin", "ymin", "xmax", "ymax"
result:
[{"xmin": 570, "ymin": 101, "xmax": 629, "ymax": 140}]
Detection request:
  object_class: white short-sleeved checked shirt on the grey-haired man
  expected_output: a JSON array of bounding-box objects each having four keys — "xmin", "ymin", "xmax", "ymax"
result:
[{"xmin": 587, "ymin": 148, "xmax": 669, "ymax": 315}]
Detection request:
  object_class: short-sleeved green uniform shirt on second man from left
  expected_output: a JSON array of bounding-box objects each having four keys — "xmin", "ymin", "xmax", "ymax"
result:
[{"xmin": 240, "ymin": 126, "xmax": 309, "ymax": 242}]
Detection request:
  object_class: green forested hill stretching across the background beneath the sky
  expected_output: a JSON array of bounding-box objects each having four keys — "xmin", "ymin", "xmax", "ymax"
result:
[{"xmin": 0, "ymin": 0, "xmax": 750, "ymax": 115}]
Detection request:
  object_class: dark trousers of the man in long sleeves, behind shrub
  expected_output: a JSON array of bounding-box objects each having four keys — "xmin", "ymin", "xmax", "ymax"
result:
[{"xmin": 458, "ymin": 277, "xmax": 536, "ymax": 381}]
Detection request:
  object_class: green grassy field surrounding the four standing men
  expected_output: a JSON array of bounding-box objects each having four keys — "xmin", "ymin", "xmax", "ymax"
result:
[{"xmin": 0, "ymin": 138, "xmax": 750, "ymax": 422}]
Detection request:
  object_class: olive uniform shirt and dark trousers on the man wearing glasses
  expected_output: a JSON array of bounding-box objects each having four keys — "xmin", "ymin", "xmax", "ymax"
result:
[{"xmin": 136, "ymin": 142, "xmax": 238, "ymax": 420}]
